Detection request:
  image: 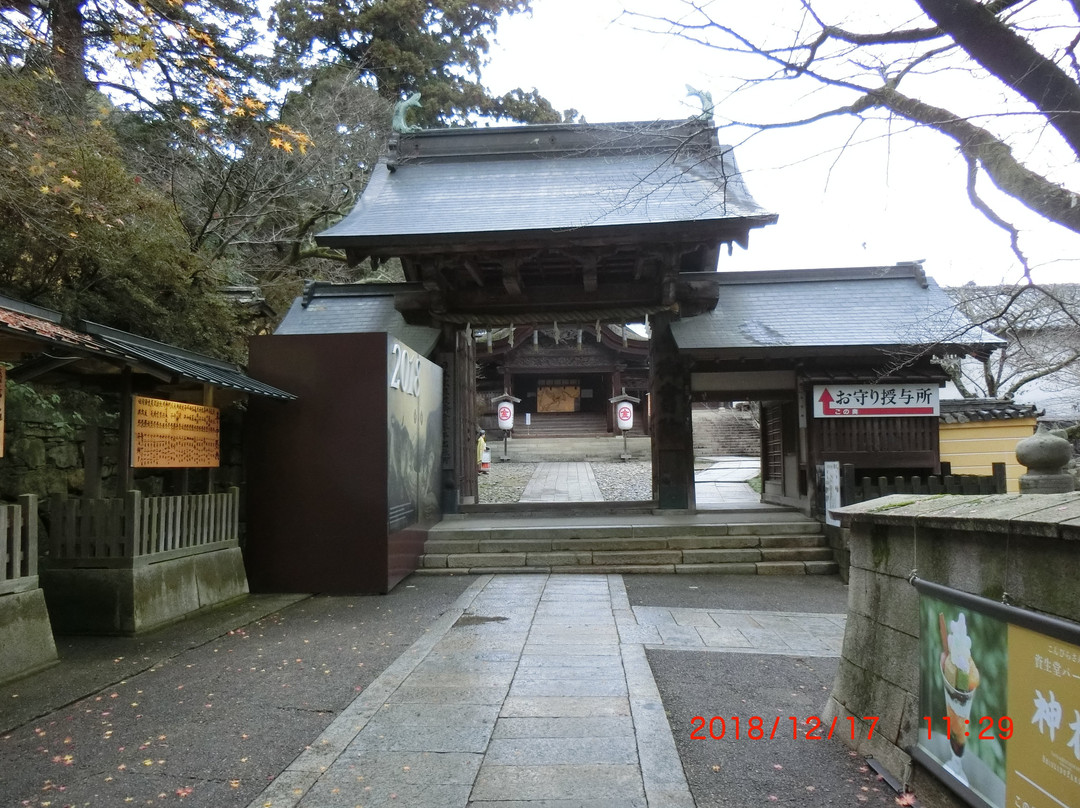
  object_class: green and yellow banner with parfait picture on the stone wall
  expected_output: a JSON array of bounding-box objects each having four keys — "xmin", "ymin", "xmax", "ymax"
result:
[{"xmin": 910, "ymin": 579, "xmax": 1080, "ymax": 808}]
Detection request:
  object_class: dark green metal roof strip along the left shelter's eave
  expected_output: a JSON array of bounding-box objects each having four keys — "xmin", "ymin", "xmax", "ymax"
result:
[{"xmin": 80, "ymin": 321, "xmax": 296, "ymax": 400}]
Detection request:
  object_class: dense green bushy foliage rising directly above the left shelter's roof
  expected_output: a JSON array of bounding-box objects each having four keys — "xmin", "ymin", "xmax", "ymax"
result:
[{"xmin": 0, "ymin": 71, "xmax": 237, "ymax": 354}]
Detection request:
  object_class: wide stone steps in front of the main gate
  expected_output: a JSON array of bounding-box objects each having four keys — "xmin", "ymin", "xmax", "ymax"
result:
[{"xmin": 418, "ymin": 511, "xmax": 838, "ymax": 575}]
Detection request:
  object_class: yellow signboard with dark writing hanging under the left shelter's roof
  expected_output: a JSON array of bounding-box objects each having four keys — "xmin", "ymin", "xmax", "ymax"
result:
[{"xmin": 132, "ymin": 395, "xmax": 221, "ymax": 469}]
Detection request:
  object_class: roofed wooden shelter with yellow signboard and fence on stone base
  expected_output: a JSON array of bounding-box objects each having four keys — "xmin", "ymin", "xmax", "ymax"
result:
[{"xmin": 0, "ymin": 297, "xmax": 293, "ymax": 652}]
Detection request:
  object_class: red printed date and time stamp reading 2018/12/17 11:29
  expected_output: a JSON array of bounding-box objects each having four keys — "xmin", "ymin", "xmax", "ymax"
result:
[{"xmin": 690, "ymin": 715, "xmax": 1013, "ymax": 741}]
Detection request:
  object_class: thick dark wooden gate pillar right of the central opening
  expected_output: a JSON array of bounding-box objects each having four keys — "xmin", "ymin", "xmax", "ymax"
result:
[{"xmin": 649, "ymin": 313, "xmax": 696, "ymax": 510}]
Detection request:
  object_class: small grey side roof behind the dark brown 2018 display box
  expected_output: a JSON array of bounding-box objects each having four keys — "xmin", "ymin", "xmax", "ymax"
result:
[{"xmin": 274, "ymin": 284, "xmax": 438, "ymax": 356}]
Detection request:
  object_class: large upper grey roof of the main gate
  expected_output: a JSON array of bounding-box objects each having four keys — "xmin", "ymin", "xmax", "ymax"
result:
[{"xmin": 318, "ymin": 121, "xmax": 775, "ymax": 246}]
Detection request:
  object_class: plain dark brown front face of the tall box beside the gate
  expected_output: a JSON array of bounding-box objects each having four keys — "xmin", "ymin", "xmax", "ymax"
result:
[{"xmin": 244, "ymin": 334, "xmax": 391, "ymax": 593}]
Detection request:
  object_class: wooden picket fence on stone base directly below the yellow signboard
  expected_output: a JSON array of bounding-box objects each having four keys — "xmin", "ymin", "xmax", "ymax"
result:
[{"xmin": 49, "ymin": 488, "xmax": 240, "ymax": 566}]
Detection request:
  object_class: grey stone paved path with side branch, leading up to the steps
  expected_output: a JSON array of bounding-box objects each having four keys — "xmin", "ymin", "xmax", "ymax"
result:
[{"xmin": 251, "ymin": 575, "xmax": 843, "ymax": 808}]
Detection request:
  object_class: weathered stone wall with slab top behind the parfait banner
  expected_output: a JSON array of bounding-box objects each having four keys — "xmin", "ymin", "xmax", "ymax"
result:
[{"xmin": 828, "ymin": 493, "xmax": 1080, "ymax": 806}]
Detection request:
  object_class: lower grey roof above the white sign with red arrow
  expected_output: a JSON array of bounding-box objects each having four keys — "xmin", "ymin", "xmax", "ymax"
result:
[{"xmin": 672, "ymin": 265, "xmax": 1004, "ymax": 353}]
